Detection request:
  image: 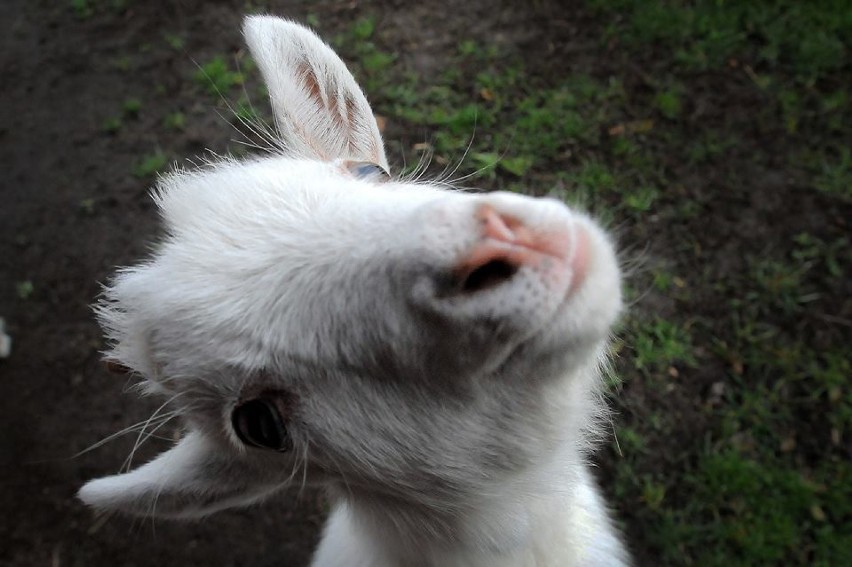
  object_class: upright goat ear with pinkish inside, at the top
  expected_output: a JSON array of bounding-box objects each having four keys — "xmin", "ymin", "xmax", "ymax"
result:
[{"xmin": 243, "ymin": 16, "xmax": 388, "ymax": 170}]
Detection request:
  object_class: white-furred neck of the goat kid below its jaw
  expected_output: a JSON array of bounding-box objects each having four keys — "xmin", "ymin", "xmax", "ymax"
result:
[{"xmin": 313, "ymin": 454, "xmax": 627, "ymax": 567}]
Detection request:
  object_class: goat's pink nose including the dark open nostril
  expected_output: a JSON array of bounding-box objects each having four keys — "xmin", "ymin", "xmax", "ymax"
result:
[{"xmin": 456, "ymin": 204, "xmax": 588, "ymax": 292}]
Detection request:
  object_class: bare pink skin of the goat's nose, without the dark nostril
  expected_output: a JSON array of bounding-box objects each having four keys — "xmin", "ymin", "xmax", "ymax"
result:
[{"xmin": 456, "ymin": 205, "xmax": 589, "ymax": 292}]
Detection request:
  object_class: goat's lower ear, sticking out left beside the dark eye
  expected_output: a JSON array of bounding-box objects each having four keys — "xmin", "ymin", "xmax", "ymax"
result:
[{"xmin": 78, "ymin": 432, "xmax": 281, "ymax": 518}]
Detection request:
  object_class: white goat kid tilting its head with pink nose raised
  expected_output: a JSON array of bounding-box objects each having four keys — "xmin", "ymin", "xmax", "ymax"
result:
[{"xmin": 80, "ymin": 16, "xmax": 627, "ymax": 567}]
